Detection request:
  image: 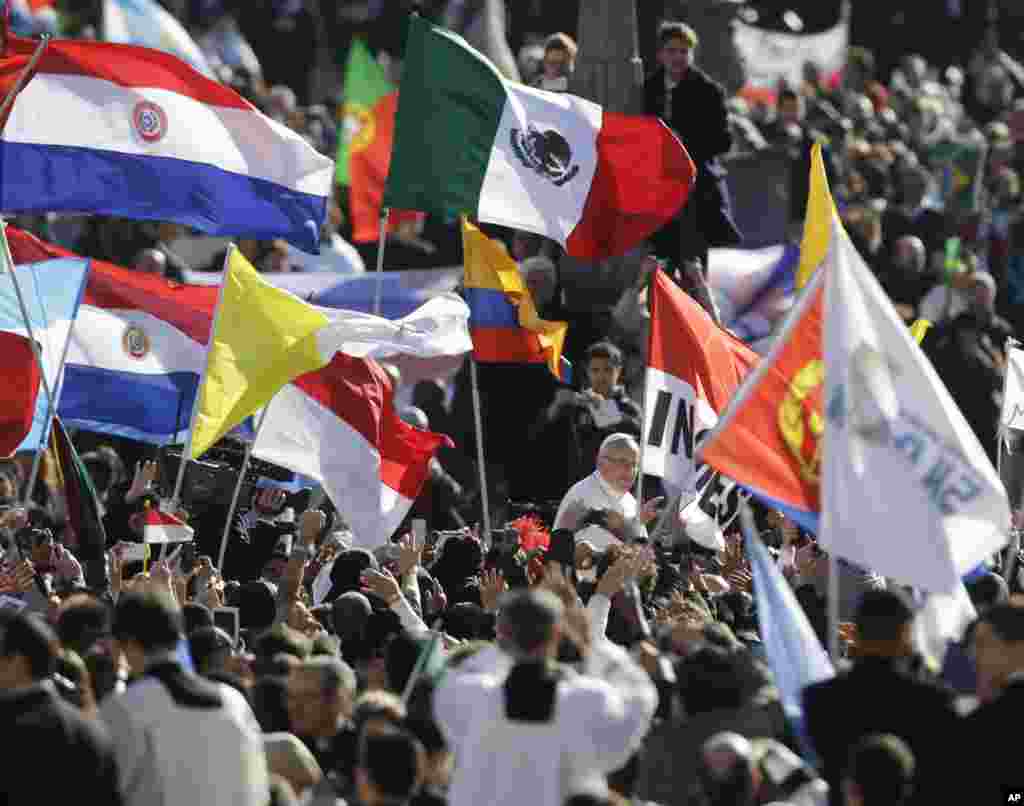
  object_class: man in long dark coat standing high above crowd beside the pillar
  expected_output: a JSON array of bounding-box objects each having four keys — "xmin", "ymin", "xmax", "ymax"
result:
[{"xmin": 644, "ymin": 23, "xmax": 741, "ymax": 272}]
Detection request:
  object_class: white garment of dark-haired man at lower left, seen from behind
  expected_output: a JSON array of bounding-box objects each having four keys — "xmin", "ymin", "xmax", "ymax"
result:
[{"xmin": 99, "ymin": 663, "xmax": 269, "ymax": 806}]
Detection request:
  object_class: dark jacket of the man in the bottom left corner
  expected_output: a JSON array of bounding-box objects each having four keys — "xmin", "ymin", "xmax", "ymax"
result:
[{"xmin": 0, "ymin": 685, "xmax": 121, "ymax": 806}]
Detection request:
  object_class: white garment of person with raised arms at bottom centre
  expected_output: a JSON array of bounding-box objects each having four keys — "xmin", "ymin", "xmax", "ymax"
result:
[{"xmin": 434, "ymin": 641, "xmax": 657, "ymax": 806}]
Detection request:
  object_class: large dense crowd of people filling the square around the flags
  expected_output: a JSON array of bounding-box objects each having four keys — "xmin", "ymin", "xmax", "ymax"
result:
[{"xmin": 6, "ymin": 0, "xmax": 1024, "ymax": 806}]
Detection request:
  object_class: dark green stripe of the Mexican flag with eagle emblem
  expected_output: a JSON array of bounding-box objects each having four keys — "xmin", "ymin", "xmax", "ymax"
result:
[{"xmin": 384, "ymin": 14, "xmax": 507, "ymax": 218}]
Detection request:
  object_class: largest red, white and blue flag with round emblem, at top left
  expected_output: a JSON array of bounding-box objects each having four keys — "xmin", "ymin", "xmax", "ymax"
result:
[{"xmin": 0, "ymin": 37, "xmax": 334, "ymax": 253}]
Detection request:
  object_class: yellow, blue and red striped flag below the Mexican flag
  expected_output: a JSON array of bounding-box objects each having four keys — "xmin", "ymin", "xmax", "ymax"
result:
[{"xmin": 462, "ymin": 220, "xmax": 568, "ymax": 380}]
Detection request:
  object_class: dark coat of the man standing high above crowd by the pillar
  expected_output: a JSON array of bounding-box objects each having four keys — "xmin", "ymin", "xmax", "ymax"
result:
[{"xmin": 644, "ymin": 67, "xmax": 741, "ymax": 247}]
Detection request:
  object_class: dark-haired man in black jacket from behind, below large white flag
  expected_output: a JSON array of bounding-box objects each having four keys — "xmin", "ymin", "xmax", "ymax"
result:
[{"xmin": 804, "ymin": 590, "xmax": 965, "ymax": 806}]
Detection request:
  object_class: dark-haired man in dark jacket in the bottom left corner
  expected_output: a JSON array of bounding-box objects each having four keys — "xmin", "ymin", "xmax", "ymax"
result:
[{"xmin": 0, "ymin": 611, "xmax": 121, "ymax": 806}]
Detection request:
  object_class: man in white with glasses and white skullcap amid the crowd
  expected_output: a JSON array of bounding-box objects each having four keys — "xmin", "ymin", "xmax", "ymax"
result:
[{"xmin": 554, "ymin": 433, "xmax": 664, "ymax": 551}]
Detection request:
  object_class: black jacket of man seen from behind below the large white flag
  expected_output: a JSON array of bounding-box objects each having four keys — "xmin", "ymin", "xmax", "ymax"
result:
[{"xmin": 804, "ymin": 657, "xmax": 962, "ymax": 806}]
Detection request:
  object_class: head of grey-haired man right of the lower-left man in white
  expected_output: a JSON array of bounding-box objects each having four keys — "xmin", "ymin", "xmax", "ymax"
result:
[{"xmin": 287, "ymin": 655, "xmax": 356, "ymax": 738}]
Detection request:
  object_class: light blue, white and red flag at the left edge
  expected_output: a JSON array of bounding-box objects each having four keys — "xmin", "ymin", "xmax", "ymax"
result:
[{"xmin": 0, "ymin": 247, "xmax": 89, "ymax": 455}]
